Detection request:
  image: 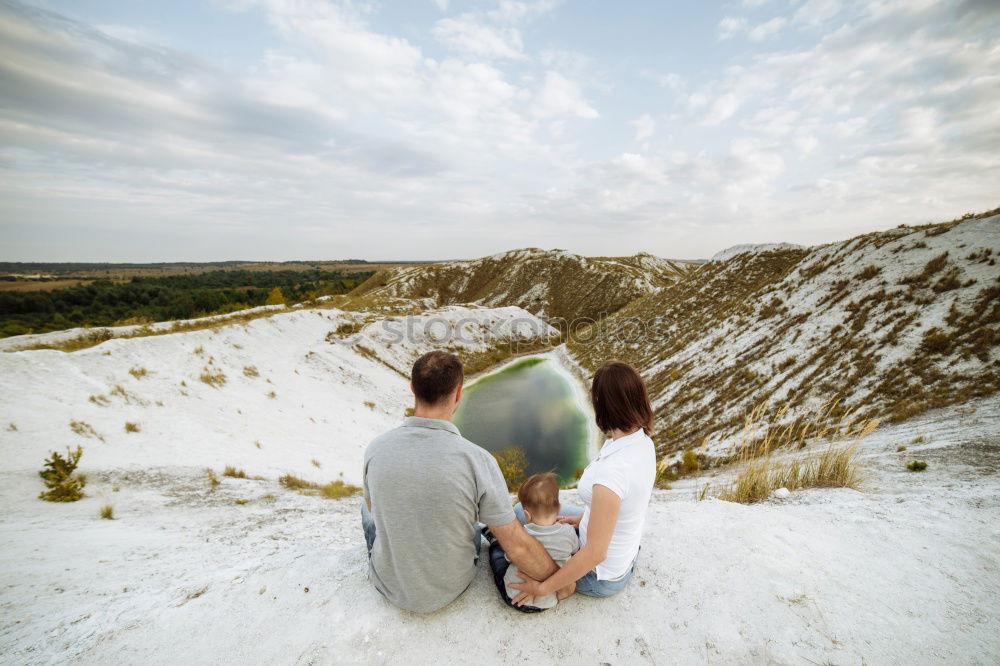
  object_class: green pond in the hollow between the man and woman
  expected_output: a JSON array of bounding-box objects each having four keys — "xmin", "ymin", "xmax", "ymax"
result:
[{"xmin": 454, "ymin": 358, "xmax": 591, "ymax": 483}]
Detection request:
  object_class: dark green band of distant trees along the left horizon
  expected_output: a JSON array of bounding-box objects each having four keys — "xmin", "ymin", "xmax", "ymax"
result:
[{"xmin": 0, "ymin": 269, "xmax": 371, "ymax": 337}]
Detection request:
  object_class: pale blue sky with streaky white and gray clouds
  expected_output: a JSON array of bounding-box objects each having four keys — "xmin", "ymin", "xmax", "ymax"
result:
[{"xmin": 0, "ymin": 0, "xmax": 1000, "ymax": 262}]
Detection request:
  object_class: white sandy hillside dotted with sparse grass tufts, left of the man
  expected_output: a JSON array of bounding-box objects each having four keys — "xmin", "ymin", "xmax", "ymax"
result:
[{"xmin": 0, "ymin": 307, "xmax": 555, "ymax": 482}]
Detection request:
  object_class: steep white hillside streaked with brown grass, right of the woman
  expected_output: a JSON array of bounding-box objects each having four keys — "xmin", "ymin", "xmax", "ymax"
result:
[{"xmin": 569, "ymin": 211, "xmax": 1000, "ymax": 452}]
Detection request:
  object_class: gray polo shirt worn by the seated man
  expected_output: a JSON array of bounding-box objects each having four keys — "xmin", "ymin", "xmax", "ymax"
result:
[{"xmin": 364, "ymin": 416, "xmax": 514, "ymax": 613}]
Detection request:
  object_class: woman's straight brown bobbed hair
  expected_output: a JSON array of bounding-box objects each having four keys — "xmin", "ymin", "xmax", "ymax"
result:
[{"xmin": 590, "ymin": 361, "xmax": 653, "ymax": 435}]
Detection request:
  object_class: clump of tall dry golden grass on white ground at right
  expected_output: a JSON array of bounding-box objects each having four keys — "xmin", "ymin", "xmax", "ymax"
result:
[{"xmin": 703, "ymin": 400, "xmax": 879, "ymax": 504}]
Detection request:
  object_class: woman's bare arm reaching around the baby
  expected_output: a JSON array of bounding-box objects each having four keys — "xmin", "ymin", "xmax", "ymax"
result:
[{"xmin": 510, "ymin": 484, "xmax": 622, "ymax": 606}]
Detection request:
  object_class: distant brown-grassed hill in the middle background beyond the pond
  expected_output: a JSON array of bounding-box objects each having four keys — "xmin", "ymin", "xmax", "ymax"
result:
[{"xmin": 351, "ymin": 248, "xmax": 696, "ymax": 321}]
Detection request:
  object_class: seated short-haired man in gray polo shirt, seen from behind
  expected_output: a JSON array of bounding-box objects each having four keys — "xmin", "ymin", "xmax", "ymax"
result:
[{"xmin": 361, "ymin": 351, "xmax": 557, "ymax": 613}]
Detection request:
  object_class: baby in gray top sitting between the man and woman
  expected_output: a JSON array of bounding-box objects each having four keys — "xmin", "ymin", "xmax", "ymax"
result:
[{"xmin": 503, "ymin": 474, "xmax": 580, "ymax": 608}]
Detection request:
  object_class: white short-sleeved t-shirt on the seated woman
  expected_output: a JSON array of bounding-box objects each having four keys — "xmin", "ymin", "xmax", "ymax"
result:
[{"xmin": 577, "ymin": 428, "xmax": 656, "ymax": 580}]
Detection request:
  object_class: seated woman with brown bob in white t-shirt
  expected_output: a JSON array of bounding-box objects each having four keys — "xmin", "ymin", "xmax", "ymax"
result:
[{"xmin": 510, "ymin": 361, "xmax": 656, "ymax": 607}]
